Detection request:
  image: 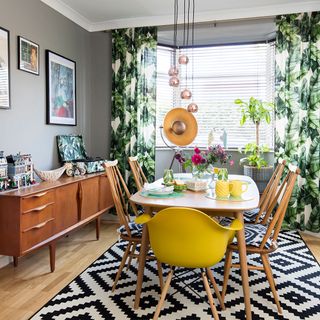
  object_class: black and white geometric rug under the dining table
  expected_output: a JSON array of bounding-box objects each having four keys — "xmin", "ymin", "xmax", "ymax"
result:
[{"xmin": 32, "ymin": 232, "xmax": 320, "ymax": 320}]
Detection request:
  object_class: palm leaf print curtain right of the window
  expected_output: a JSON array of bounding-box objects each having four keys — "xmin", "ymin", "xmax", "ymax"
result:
[{"xmin": 276, "ymin": 12, "xmax": 320, "ymax": 232}]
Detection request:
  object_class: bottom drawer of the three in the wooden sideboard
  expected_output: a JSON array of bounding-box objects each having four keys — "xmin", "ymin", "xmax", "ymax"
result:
[{"xmin": 21, "ymin": 218, "xmax": 54, "ymax": 252}]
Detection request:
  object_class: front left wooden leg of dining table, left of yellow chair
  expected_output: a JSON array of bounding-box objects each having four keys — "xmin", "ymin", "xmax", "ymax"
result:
[{"xmin": 134, "ymin": 224, "xmax": 149, "ymax": 309}]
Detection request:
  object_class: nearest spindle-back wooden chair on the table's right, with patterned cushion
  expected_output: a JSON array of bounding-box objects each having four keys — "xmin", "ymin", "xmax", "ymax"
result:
[{"xmin": 222, "ymin": 166, "xmax": 300, "ymax": 314}]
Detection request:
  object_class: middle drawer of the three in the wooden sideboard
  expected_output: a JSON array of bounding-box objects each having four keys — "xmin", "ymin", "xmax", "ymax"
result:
[{"xmin": 21, "ymin": 202, "xmax": 54, "ymax": 231}]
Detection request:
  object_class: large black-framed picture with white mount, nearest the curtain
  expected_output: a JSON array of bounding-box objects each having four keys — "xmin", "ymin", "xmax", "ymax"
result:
[{"xmin": 46, "ymin": 50, "xmax": 77, "ymax": 126}]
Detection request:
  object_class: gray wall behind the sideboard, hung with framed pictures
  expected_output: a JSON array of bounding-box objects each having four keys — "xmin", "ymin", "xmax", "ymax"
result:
[{"xmin": 0, "ymin": 0, "xmax": 111, "ymax": 169}]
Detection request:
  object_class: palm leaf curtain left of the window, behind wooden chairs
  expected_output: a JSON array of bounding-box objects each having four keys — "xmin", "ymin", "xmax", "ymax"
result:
[{"xmin": 110, "ymin": 27, "xmax": 157, "ymax": 192}]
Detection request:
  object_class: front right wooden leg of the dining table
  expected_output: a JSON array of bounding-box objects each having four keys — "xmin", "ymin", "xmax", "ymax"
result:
[{"xmin": 235, "ymin": 212, "xmax": 251, "ymax": 320}]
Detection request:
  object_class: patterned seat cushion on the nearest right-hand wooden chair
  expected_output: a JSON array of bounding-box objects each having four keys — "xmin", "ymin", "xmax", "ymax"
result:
[{"xmin": 220, "ymin": 218, "xmax": 272, "ymax": 249}]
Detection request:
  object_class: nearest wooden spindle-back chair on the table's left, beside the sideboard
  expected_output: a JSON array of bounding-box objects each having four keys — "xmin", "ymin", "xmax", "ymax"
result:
[{"xmin": 104, "ymin": 160, "xmax": 163, "ymax": 291}]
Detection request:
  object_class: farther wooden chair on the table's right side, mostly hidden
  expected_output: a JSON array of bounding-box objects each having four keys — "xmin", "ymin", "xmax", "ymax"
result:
[{"xmin": 243, "ymin": 159, "xmax": 286, "ymax": 224}]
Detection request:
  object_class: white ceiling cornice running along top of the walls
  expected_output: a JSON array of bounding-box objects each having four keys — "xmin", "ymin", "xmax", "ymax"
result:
[{"xmin": 41, "ymin": 0, "xmax": 320, "ymax": 32}]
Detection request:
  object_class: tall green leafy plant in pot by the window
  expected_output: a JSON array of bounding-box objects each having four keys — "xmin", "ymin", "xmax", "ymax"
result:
[{"xmin": 234, "ymin": 97, "xmax": 274, "ymax": 193}]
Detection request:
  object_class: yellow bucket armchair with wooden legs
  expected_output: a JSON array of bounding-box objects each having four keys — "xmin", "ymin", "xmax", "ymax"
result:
[{"xmin": 136, "ymin": 207, "xmax": 243, "ymax": 320}]
